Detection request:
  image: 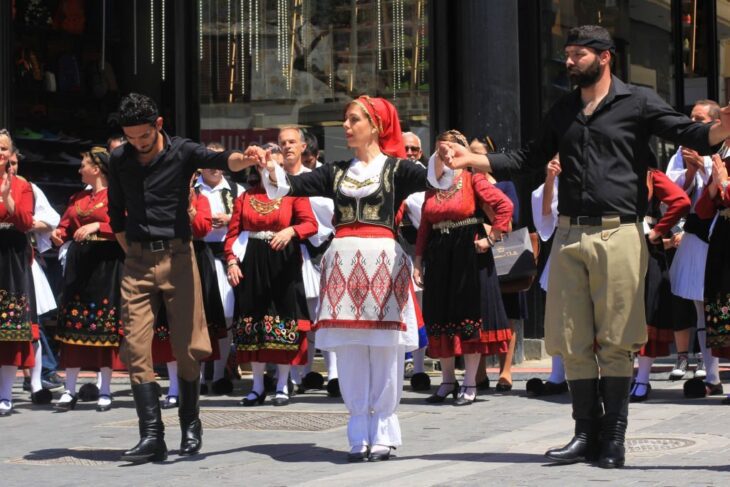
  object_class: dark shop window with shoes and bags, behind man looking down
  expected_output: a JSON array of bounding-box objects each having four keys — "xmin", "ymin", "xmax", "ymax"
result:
[{"xmin": 10, "ymin": 0, "xmax": 174, "ymax": 212}]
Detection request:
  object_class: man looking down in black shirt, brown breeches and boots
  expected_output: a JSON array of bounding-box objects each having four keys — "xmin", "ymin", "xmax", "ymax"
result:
[{"xmin": 109, "ymin": 93, "xmax": 253, "ymax": 462}]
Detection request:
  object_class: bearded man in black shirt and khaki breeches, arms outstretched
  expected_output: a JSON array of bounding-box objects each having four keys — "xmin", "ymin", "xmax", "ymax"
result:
[{"xmin": 439, "ymin": 26, "xmax": 730, "ymax": 468}]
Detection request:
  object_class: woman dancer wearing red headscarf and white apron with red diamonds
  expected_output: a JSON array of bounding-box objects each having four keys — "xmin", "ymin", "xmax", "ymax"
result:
[{"xmin": 253, "ymin": 96, "xmax": 451, "ymax": 461}]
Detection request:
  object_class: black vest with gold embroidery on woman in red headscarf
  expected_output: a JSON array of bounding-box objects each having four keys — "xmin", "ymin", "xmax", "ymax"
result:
[{"xmin": 334, "ymin": 157, "xmax": 399, "ymax": 230}]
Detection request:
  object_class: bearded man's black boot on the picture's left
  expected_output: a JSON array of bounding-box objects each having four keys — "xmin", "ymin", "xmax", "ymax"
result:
[{"xmin": 545, "ymin": 379, "xmax": 602, "ymax": 464}]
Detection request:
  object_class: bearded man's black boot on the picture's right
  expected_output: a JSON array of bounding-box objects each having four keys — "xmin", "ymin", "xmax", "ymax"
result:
[{"xmin": 598, "ymin": 377, "xmax": 631, "ymax": 468}]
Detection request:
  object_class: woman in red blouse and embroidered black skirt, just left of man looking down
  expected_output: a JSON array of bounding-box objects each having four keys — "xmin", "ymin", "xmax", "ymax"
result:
[{"xmin": 51, "ymin": 147, "xmax": 124, "ymax": 411}]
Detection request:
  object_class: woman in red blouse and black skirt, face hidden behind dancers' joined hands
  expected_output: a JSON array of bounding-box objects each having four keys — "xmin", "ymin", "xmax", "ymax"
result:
[{"xmin": 225, "ymin": 175, "xmax": 317, "ymax": 406}]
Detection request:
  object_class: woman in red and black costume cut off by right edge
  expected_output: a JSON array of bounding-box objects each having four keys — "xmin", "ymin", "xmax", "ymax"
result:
[{"xmin": 695, "ymin": 152, "xmax": 730, "ymax": 404}]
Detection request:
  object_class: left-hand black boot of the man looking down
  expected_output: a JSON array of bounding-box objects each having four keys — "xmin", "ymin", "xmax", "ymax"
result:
[{"xmin": 122, "ymin": 382, "xmax": 167, "ymax": 463}]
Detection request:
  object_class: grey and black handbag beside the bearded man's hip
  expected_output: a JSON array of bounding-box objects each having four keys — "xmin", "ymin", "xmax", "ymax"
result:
[{"xmin": 492, "ymin": 227, "xmax": 538, "ymax": 293}]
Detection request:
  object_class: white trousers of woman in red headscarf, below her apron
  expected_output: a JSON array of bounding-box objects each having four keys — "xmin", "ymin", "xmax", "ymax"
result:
[{"xmin": 335, "ymin": 345, "xmax": 405, "ymax": 447}]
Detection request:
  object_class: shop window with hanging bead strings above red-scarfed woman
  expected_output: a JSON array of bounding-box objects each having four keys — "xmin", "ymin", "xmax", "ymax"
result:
[{"xmin": 194, "ymin": 0, "xmax": 430, "ymax": 161}]
